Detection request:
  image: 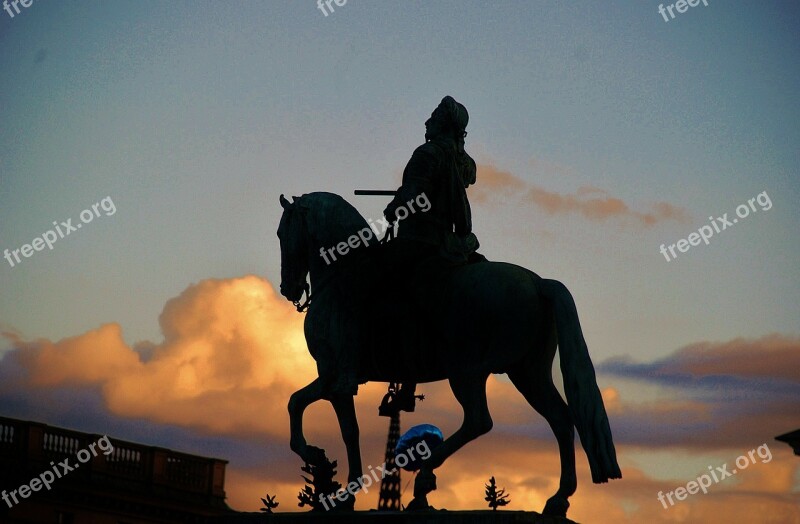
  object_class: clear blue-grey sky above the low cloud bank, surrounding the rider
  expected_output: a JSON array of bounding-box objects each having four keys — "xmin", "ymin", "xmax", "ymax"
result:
[{"xmin": 0, "ymin": 0, "xmax": 800, "ymax": 520}]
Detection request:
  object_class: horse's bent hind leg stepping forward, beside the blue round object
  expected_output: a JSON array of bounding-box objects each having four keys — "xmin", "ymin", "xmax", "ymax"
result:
[{"xmin": 407, "ymin": 374, "xmax": 492, "ymax": 511}]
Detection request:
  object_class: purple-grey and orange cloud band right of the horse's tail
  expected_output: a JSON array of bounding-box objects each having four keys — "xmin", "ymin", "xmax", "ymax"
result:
[{"xmin": 597, "ymin": 334, "xmax": 800, "ymax": 449}]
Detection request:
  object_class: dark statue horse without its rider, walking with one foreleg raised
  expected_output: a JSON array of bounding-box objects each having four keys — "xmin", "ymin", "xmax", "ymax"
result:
[{"xmin": 278, "ymin": 192, "xmax": 622, "ymax": 516}]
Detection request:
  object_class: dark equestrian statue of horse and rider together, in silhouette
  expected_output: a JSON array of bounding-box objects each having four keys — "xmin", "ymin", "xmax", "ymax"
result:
[{"xmin": 278, "ymin": 96, "xmax": 622, "ymax": 516}]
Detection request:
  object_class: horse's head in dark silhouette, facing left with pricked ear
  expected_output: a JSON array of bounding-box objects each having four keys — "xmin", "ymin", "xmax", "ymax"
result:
[{"xmin": 278, "ymin": 195, "xmax": 309, "ymax": 306}]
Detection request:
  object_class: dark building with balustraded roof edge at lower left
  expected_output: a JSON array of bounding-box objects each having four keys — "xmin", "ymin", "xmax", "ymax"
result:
[{"xmin": 0, "ymin": 417, "xmax": 232, "ymax": 524}]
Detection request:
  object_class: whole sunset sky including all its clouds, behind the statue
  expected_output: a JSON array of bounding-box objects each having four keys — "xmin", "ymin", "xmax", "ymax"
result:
[{"xmin": 0, "ymin": 0, "xmax": 800, "ymax": 523}]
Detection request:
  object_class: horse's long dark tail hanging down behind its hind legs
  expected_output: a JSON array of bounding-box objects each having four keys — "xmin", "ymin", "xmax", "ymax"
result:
[{"xmin": 540, "ymin": 279, "xmax": 622, "ymax": 484}]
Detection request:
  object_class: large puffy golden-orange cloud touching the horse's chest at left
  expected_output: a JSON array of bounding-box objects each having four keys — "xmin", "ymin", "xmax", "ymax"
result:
[{"xmin": 2, "ymin": 276, "xmax": 315, "ymax": 436}]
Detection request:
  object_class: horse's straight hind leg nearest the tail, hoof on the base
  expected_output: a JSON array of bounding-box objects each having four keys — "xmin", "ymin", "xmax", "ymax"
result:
[{"xmin": 508, "ymin": 364, "xmax": 578, "ymax": 517}]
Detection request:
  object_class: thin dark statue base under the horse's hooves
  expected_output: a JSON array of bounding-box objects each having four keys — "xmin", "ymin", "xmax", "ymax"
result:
[{"xmin": 212, "ymin": 510, "xmax": 577, "ymax": 524}]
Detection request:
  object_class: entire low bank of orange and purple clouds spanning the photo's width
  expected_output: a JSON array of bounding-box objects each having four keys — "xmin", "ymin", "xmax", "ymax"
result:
[{"xmin": 0, "ymin": 276, "xmax": 800, "ymax": 523}]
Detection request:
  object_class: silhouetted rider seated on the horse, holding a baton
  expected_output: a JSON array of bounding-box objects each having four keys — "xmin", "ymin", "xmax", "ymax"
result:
[{"xmin": 383, "ymin": 96, "xmax": 485, "ymax": 411}]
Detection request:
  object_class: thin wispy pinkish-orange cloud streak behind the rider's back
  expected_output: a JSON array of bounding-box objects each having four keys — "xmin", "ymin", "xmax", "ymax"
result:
[{"xmin": 469, "ymin": 164, "xmax": 689, "ymax": 226}]
